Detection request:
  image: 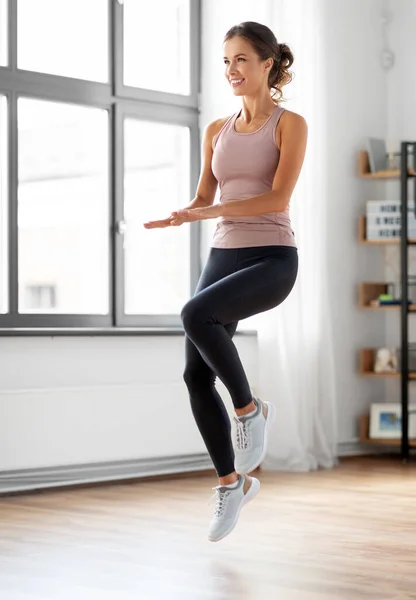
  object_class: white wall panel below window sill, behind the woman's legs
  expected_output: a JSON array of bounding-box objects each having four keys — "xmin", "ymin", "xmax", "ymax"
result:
[{"xmin": 0, "ymin": 336, "xmax": 257, "ymax": 471}]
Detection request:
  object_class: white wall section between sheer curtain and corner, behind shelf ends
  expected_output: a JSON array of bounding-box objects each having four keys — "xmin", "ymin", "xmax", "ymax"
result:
[{"xmin": 317, "ymin": 0, "xmax": 388, "ymax": 443}]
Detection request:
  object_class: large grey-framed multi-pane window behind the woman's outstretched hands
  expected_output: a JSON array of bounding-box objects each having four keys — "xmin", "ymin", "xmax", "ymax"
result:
[{"xmin": 0, "ymin": 0, "xmax": 200, "ymax": 335}]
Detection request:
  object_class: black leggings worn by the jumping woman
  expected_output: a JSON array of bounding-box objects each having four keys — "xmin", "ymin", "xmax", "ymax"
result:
[{"xmin": 181, "ymin": 246, "xmax": 298, "ymax": 477}]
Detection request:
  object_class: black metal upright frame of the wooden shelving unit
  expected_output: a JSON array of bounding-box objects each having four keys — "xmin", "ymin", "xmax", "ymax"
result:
[{"xmin": 400, "ymin": 142, "xmax": 416, "ymax": 462}]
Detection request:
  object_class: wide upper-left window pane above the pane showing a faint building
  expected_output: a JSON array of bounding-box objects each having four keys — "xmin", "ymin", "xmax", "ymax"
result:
[{"xmin": 17, "ymin": 0, "xmax": 108, "ymax": 82}]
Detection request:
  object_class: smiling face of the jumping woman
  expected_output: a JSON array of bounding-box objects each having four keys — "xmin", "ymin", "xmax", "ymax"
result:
[{"xmin": 224, "ymin": 37, "xmax": 273, "ymax": 96}]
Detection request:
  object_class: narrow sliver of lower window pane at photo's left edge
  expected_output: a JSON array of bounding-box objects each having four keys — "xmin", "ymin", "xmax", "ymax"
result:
[{"xmin": 0, "ymin": 96, "xmax": 9, "ymax": 313}]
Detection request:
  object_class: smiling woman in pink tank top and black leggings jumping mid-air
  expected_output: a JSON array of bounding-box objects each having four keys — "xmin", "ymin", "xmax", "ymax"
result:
[{"xmin": 144, "ymin": 22, "xmax": 307, "ymax": 541}]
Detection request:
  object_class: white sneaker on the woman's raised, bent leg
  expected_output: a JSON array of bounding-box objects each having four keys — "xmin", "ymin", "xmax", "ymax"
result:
[{"xmin": 233, "ymin": 398, "xmax": 276, "ymax": 474}]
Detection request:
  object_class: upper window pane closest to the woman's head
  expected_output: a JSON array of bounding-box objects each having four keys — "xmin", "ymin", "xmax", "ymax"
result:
[{"xmin": 124, "ymin": 0, "xmax": 190, "ymax": 95}]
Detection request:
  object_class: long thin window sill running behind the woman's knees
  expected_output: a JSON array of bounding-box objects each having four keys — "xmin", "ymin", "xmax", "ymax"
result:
[{"xmin": 0, "ymin": 327, "xmax": 257, "ymax": 337}]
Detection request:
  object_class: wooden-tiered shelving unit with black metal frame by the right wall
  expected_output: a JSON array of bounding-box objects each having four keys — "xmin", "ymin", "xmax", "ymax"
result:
[{"xmin": 357, "ymin": 141, "xmax": 416, "ymax": 460}]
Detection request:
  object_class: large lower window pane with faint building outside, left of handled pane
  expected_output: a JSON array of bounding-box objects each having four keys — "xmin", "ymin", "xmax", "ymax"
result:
[{"xmin": 18, "ymin": 98, "xmax": 109, "ymax": 314}]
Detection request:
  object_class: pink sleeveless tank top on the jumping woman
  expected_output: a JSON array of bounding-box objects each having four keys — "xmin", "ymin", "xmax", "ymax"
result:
[{"xmin": 211, "ymin": 106, "xmax": 296, "ymax": 248}]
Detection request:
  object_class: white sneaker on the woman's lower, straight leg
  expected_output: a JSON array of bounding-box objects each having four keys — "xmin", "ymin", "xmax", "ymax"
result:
[{"xmin": 208, "ymin": 475, "xmax": 260, "ymax": 542}]
